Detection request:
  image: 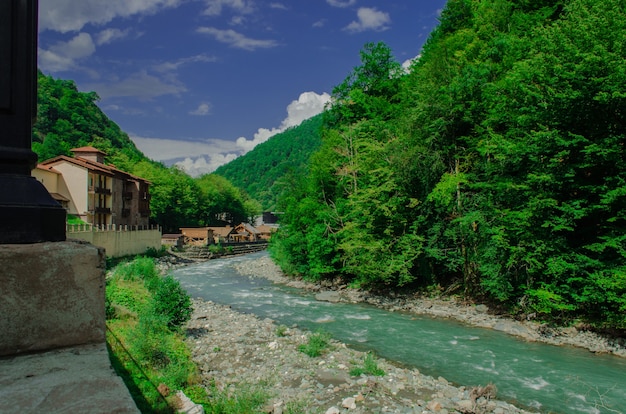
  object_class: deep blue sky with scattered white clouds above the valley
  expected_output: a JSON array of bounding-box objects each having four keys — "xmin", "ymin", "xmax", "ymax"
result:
[{"xmin": 39, "ymin": 0, "xmax": 445, "ymax": 176}]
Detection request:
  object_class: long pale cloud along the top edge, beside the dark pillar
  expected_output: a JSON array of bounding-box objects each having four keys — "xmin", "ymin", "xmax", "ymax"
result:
[{"xmin": 39, "ymin": 0, "xmax": 184, "ymax": 33}]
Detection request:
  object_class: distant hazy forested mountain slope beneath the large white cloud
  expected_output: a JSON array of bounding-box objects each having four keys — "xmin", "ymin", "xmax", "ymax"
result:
[{"xmin": 215, "ymin": 114, "xmax": 322, "ymax": 211}]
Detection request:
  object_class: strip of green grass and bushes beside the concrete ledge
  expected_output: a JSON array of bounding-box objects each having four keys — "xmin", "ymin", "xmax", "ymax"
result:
[{"xmin": 106, "ymin": 257, "xmax": 199, "ymax": 413}]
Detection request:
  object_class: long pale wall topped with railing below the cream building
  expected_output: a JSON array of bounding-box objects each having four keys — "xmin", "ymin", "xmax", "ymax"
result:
[{"xmin": 67, "ymin": 224, "xmax": 161, "ymax": 257}]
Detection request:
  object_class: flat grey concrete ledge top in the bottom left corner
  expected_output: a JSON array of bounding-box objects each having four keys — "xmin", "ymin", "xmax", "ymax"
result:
[{"xmin": 0, "ymin": 343, "xmax": 139, "ymax": 414}]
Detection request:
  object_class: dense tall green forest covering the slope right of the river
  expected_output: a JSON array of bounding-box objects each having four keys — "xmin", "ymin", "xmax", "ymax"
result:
[{"xmin": 272, "ymin": 0, "xmax": 626, "ymax": 329}]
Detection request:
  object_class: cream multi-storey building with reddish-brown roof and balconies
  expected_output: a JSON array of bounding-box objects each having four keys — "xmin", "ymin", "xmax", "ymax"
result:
[{"xmin": 32, "ymin": 147, "xmax": 150, "ymax": 226}]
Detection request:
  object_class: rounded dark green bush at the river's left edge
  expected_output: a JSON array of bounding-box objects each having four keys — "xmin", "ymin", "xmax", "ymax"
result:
[{"xmin": 154, "ymin": 276, "xmax": 193, "ymax": 330}]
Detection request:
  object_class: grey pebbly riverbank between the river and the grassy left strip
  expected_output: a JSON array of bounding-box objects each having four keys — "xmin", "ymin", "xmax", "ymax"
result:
[{"xmin": 187, "ymin": 300, "xmax": 527, "ymax": 414}]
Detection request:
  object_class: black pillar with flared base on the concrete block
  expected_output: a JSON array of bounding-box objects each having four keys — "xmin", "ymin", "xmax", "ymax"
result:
[{"xmin": 0, "ymin": 0, "xmax": 65, "ymax": 244}]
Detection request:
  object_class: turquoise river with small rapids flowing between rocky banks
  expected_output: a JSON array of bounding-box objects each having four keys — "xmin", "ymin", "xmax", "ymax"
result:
[{"xmin": 172, "ymin": 252, "xmax": 626, "ymax": 413}]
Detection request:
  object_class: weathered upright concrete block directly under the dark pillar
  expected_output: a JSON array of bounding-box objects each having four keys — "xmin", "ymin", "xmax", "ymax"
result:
[{"xmin": 0, "ymin": 241, "xmax": 106, "ymax": 356}]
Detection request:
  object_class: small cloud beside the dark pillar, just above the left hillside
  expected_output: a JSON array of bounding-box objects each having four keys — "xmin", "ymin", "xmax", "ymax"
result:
[{"xmin": 38, "ymin": 33, "xmax": 96, "ymax": 72}]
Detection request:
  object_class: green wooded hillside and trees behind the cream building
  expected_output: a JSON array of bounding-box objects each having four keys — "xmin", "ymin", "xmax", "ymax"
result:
[{"xmin": 32, "ymin": 72, "xmax": 260, "ymax": 233}]
